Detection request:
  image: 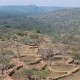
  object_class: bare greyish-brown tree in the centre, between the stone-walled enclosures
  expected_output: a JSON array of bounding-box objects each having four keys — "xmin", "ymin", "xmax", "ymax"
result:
[{"xmin": 38, "ymin": 43, "xmax": 53, "ymax": 60}]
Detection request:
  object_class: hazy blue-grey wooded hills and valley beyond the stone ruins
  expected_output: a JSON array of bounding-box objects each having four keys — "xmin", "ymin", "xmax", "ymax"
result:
[{"xmin": 0, "ymin": 5, "xmax": 80, "ymax": 45}]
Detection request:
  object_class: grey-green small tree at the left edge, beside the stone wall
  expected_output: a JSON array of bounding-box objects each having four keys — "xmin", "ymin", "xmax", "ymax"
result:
[{"xmin": 0, "ymin": 51, "xmax": 13, "ymax": 75}]
